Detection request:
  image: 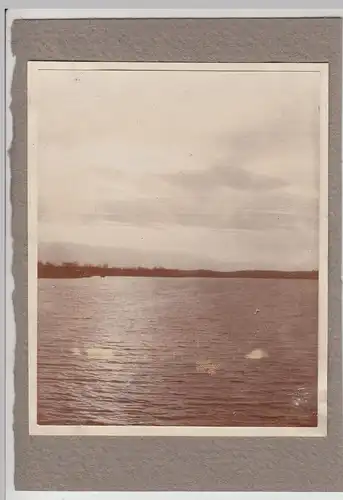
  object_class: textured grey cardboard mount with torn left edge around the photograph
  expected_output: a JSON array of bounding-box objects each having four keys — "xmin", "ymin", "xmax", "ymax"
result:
[{"xmin": 11, "ymin": 18, "xmax": 343, "ymax": 491}]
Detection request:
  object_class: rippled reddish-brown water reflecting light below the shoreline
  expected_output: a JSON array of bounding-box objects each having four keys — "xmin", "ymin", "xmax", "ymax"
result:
[{"xmin": 38, "ymin": 277, "xmax": 318, "ymax": 426}]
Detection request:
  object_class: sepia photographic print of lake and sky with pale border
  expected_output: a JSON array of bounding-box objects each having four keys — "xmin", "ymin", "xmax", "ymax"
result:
[{"xmin": 28, "ymin": 62, "xmax": 328, "ymax": 436}]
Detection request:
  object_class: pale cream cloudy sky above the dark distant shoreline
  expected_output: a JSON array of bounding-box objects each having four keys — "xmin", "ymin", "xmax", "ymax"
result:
[{"xmin": 38, "ymin": 66, "xmax": 319, "ymax": 270}]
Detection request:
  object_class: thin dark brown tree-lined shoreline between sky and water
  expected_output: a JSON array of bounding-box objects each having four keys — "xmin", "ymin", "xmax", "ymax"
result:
[{"xmin": 37, "ymin": 262, "xmax": 318, "ymax": 280}]
